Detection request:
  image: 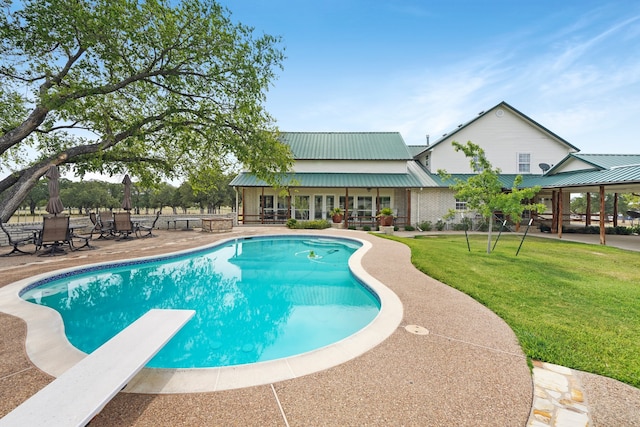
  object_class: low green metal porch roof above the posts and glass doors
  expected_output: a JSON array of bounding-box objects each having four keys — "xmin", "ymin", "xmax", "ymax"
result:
[{"xmin": 230, "ymin": 172, "xmax": 421, "ymax": 188}]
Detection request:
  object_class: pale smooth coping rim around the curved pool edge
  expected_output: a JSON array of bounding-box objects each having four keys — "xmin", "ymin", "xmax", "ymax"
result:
[{"xmin": 0, "ymin": 234, "xmax": 403, "ymax": 394}]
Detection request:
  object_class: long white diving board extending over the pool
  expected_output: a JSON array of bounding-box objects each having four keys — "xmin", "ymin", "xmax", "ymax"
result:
[{"xmin": 0, "ymin": 309, "xmax": 195, "ymax": 427}]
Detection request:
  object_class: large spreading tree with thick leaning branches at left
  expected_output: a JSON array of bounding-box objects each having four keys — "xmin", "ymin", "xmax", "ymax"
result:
[{"xmin": 0, "ymin": 0, "xmax": 292, "ymax": 220}]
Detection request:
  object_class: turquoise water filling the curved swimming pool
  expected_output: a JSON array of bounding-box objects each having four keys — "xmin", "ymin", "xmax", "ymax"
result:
[{"xmin": 21, "ymin": 236, "xmax": 380, "ymax": 368}]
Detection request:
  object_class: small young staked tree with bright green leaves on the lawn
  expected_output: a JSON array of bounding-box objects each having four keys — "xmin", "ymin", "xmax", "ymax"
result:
[{"xmin": 438, "ymin": 141, "xmax": 545, "ymax": 253}]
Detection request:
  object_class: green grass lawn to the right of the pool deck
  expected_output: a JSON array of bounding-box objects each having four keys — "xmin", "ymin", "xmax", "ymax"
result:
[{"xmin": 384, "ymin": 234, "xmax": 640, "ymax": 387}]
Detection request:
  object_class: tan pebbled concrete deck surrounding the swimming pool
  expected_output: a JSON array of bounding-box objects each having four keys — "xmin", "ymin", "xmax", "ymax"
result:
[{"xmin": 0, "ymin": 226, "xmax": 640, "ymax": 426}]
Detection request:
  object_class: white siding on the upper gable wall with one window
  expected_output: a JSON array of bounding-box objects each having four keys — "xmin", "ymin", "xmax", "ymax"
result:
[{"xmin": 431, "ymin": 109, "xmax": 573, "ymax": 175}]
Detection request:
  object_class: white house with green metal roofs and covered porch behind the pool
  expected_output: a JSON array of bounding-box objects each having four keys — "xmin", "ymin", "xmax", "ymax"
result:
[{"xmin": 231, "ymin": 102, "xmax": 640, "ymax": 231}]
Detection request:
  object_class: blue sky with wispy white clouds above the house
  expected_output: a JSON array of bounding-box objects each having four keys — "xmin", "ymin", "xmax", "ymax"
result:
[{"xmin": 220, "ymin": 0, "xmax": 640, "ymax": 154}]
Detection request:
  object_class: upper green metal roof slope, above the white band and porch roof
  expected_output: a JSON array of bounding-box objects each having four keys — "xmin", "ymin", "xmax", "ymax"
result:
[{"xmin": 280, "ymin": 132, "xmax": 413, "ymax": 160}]
